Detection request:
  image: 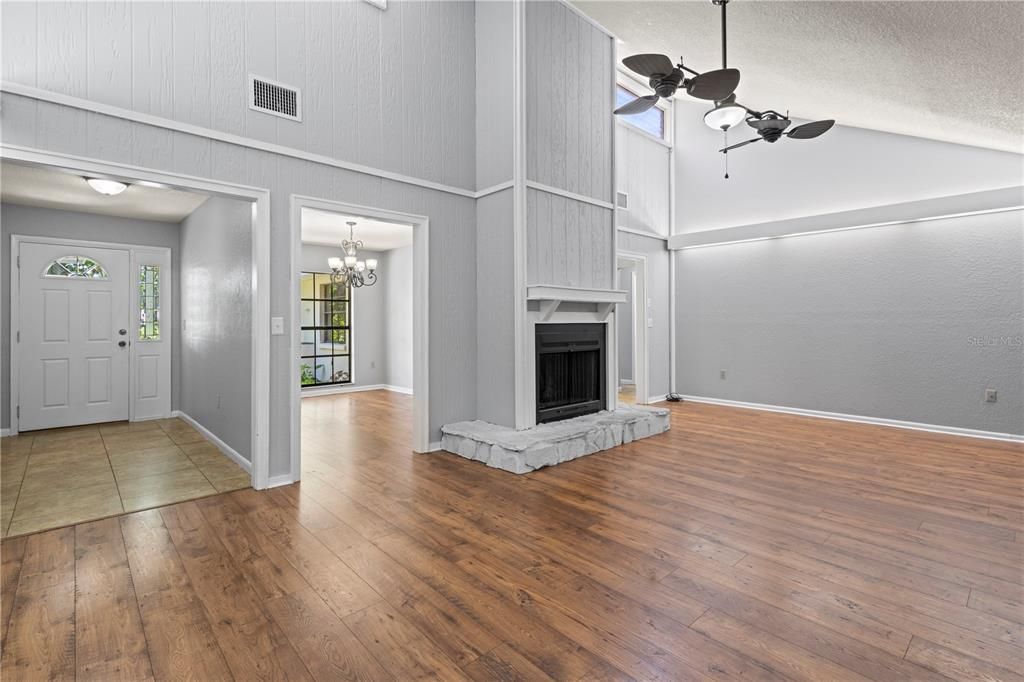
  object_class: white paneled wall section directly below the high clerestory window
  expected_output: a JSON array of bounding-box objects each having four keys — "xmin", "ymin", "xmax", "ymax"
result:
[{"xmin": 615, "ymin": 124, "xmax": 672, "ymax": 237}]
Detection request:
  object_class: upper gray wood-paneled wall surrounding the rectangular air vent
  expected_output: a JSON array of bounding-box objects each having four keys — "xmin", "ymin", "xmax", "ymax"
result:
[{"xmin": 0, "ymin": 0, "xmax": 475, "ymax": 189}]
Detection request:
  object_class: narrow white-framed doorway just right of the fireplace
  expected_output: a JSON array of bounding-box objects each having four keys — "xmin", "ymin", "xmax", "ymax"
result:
[{"xmin": 615, "ymin": 251, "xmax": 650, "ymax": 404}]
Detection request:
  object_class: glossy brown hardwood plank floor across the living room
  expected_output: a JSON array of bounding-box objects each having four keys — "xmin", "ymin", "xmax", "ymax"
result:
[{"xmin": 0, "ymin": 392, "xmax": 1024, "ymax": 682}]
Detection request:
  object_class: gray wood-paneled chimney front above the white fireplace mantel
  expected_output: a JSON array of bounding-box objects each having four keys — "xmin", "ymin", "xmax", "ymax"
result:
[{"xmin": 524, "ymin": 2, "xmax": 614, "ymax": 289}]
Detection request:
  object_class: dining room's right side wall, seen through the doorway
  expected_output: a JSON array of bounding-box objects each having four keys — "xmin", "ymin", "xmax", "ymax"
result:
[{"xmin": 381, "ymin": 246, "xmax": 413, "ymax": 390}]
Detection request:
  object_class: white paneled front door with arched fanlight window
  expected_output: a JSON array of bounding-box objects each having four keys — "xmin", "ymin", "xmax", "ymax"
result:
[{"xmin": 16, "ymin": 242, "xmax": 132, "ymax": 431}]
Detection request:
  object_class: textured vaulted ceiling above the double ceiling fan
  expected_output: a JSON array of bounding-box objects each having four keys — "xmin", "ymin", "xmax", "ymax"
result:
[{"xmin": 573, "ymin": 0, "xmax": 1024, "ymax": 153}]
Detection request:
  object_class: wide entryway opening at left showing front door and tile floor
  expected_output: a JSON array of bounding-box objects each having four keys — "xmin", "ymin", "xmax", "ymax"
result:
[{"xmin": 0, "ymin": 148, "xmax": 267, "ymax": 537}]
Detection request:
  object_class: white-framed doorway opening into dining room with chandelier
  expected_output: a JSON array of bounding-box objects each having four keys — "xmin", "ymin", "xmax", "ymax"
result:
[{"xmin": 291, "ymin": 197, "xmax": 430, "ymax": 480}]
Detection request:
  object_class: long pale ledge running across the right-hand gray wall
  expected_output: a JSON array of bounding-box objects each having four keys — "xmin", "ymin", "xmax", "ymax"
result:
[{"xmin": 669, "ymin": 185, "xmax": 1024, "ymax": 251}]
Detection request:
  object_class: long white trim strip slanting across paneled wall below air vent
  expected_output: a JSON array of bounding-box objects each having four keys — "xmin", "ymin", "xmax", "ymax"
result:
[{"xmin": 0, "ymin": 81, "xmax": 477, "ymax": 199}]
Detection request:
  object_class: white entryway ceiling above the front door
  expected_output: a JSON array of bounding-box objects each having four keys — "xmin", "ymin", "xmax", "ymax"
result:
[{"xmin": 0, "ymin": 161, "xmax": 207, "ymax": 222}]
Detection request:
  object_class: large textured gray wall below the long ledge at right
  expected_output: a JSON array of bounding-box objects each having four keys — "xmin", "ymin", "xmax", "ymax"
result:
[{"xmin": 676, "ymin": 212, "xmax": 1024, "ymax": 434}]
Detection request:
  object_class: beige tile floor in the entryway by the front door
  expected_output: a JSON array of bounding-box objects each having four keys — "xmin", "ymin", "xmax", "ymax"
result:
[{"xmin": 0, "ymin": 419, "xmax": 250, "ymax": 538}]
